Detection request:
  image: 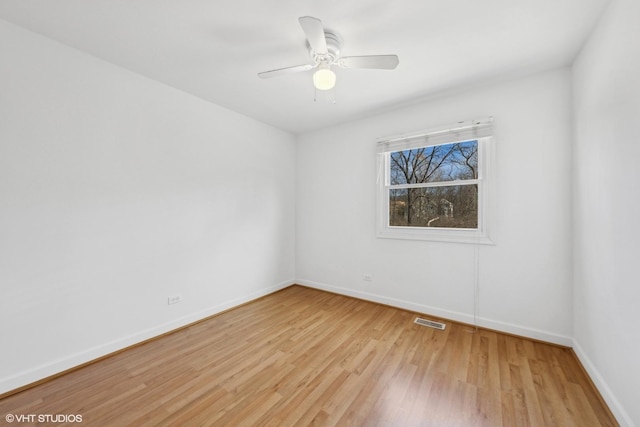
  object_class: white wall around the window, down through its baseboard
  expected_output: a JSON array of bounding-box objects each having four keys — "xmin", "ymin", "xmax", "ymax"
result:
[{"xmin": 296, "ymin": 69, "xmax": 572, "ymax": 345}]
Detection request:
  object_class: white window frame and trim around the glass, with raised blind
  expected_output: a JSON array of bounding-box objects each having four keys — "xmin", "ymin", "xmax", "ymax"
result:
[{"xmin": 376, "ymin": 119, "xmax": 495, "ymax": 245}]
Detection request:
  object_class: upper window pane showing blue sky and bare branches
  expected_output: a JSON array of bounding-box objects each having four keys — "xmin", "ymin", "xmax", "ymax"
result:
[{"xmin": 389, "ymin": 141, "xmax": 478, "ymax": 185}]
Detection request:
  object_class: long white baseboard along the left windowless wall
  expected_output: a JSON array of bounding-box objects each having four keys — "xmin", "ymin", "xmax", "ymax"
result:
[{"xmin": 0, "ymin": 280, "xmax": 295, "ymax": 394}]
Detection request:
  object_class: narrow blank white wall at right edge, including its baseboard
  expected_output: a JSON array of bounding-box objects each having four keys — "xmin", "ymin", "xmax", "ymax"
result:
[{"xmin": 574, "ymin": 0, "xmax": 640, "ymax": 425}]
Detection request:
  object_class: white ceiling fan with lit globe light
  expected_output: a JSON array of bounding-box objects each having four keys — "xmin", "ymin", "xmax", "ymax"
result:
[{"xmin": 258, "ymin": 16, "xmax": 399, "ymax": 90}]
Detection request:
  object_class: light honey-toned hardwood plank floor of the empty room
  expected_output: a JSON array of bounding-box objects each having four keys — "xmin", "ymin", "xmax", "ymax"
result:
[{"xmin": 0, "ymin": 286, "xmax": 617, "ymax": 427}]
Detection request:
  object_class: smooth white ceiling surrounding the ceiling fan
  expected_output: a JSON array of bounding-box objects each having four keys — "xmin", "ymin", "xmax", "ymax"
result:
[{"xmin": 0, "ymin": 0, "xmax": 610, "ymax": 133}]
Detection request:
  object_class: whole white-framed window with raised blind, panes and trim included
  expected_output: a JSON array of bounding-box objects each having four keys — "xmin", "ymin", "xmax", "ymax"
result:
[{"xmin": 378, "ymin": 120, "xmax": 492, "ymax": 243}]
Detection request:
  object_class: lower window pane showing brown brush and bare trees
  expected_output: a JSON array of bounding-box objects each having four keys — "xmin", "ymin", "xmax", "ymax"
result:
[{"xmin": 389, "ymin": 184, "xmax": 478, "ymax": 229}]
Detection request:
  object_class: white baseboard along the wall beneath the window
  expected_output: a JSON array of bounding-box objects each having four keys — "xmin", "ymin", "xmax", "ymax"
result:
[{"xmin": 296, "ymin": 279, "xmax": 573, "ymax": 347}]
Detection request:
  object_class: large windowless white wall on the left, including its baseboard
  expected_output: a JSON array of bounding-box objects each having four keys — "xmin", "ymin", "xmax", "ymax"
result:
[{"xmin": 0, "ymin": 21, "xmax": 295, "ymax": 393}]
